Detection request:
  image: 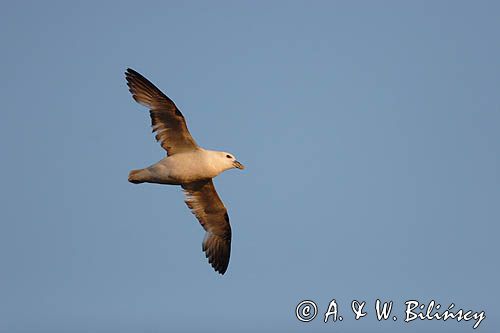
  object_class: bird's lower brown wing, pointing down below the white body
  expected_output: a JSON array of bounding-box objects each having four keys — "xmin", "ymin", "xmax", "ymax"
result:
[{"xmin": 182, "ymin": 179, "xmax": 231, "ymax": 274}]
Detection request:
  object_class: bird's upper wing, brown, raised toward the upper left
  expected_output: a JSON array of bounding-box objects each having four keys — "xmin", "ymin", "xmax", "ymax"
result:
[{"xmin": 125, "ymin": 68, "xmax": 198, "ymax": 155}]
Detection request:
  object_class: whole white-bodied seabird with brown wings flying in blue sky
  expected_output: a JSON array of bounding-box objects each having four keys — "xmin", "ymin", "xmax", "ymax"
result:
[{"xmin": 125, "ymin": 68, "xmax": 245, "ymax": 275}]
